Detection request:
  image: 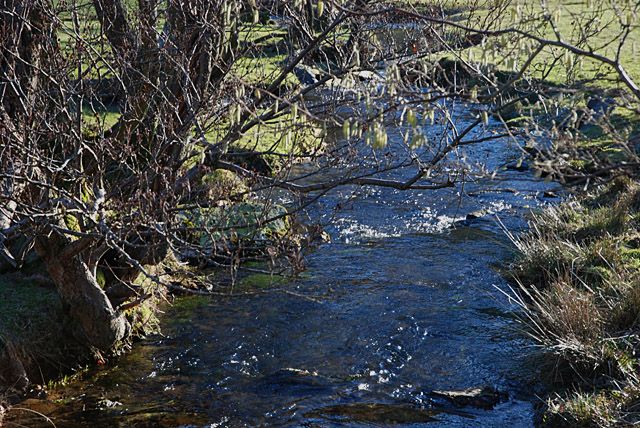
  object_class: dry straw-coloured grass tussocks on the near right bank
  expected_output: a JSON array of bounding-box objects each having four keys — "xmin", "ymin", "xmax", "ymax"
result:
[{"xmin": 512, "ymin": 179, "xmax": 640, "ymax": 426}]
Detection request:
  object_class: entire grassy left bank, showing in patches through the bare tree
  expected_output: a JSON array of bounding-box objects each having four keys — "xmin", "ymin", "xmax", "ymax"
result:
[{"xmin": 0, "ymin": 7, "xmax": 321, "ymax": 401}]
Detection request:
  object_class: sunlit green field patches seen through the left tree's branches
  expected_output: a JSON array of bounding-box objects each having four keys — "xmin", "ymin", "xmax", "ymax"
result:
[{"xmin": 58, "ymin": 2, "xmax": 317, "ymax": 170}]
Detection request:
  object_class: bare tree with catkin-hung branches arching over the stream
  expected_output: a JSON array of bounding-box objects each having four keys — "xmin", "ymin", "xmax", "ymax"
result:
[{"xmin": 0, "ymin": 0, "xmax": 640, "ymax": 358}]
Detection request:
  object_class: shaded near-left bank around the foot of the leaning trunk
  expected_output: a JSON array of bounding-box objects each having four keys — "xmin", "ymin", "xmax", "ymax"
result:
[{"xmin": 0, "ymin": 260, "xmax": 167, "ymax": 403}]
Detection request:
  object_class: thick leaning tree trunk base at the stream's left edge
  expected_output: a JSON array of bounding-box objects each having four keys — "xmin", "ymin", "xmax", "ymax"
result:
[{"xmin": 35, "ymin": 232, "xmax": 131, "ymax": 351}]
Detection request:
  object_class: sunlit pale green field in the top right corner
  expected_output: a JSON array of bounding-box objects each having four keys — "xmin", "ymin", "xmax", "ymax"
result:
[{"xmin": 444, "ymin": 0, "xmax": 640, "ymax": 87}]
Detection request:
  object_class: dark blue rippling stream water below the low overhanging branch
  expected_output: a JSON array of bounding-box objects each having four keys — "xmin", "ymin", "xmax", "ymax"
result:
[{"xmin": 13, "ymin": 104, "xmax": 560, "ymax": 427}]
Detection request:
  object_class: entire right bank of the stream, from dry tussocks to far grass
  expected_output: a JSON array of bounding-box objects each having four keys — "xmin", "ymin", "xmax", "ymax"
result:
[{"xmin": 468, "ymin": 2, "xmax": 640, "ymax": 426}]
